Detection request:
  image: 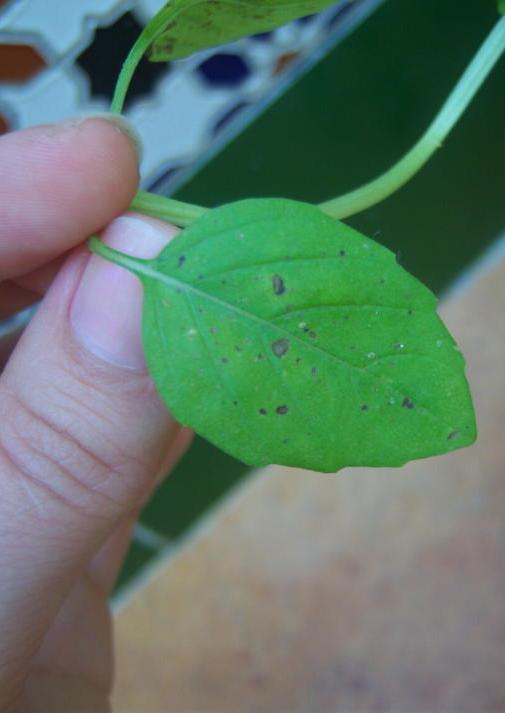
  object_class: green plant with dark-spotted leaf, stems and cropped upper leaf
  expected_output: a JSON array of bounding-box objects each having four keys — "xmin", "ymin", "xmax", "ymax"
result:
[{"xmin": 90, "ymin": 0, "xmax": 505, "ymax": 471}]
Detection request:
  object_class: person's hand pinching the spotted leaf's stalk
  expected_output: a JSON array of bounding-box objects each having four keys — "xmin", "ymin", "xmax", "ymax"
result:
[{"xmin": 0, "ymin": 119, "xmax": 191, "ymax": 713}]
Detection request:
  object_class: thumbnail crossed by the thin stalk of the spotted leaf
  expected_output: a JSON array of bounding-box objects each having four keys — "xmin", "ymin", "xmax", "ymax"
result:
[{"xmin": 70, "ymin": 215, "xmax": 173, "ymax": 370}]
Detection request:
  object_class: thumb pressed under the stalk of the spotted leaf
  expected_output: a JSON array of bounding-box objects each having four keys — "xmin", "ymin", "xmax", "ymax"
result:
[{"xmin": 0, "ymin": 215, "xmax": 179, "ymax": 688}]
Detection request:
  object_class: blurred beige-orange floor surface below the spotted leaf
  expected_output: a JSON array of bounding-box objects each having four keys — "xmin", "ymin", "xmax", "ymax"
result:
[{"xmin": 115, "ymin": 253, "xmax": 505, "ymax": 713}]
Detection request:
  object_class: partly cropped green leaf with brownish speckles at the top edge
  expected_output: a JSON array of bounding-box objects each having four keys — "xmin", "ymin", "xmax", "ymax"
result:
[{"xmin": 148, "ymin": 0, "xmax": 332, "ymax": 62}]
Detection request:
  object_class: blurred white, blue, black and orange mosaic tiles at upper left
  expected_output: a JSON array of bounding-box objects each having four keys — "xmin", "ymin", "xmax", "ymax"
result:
[{"xmin": 0, "ymin": 0, "xmax": 382, "ymax": 192}]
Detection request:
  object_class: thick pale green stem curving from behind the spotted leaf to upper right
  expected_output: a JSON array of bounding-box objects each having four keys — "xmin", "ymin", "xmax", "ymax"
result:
[{"xmin": 319, "ymin": 17, "xmax": 505, "ymax": 219}]
